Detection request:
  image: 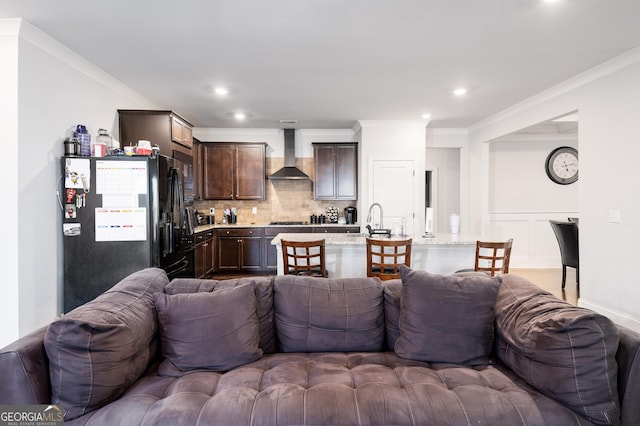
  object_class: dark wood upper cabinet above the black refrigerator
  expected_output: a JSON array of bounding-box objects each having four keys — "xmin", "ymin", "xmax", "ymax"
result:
[{"xmin": 118, "ymin": 109, "xmax": 193, "ymax": 157}]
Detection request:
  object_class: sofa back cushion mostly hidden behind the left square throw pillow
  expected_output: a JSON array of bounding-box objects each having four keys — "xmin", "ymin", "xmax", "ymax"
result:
[{"xmin": 164, "ymin": 277, "xmax": 276, "ymax": 353}]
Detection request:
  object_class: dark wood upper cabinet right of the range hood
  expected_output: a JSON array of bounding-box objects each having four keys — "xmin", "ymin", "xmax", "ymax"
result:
[{"xmin": 313, "ymin": 143, "xmax": 358, "ymax": 200}]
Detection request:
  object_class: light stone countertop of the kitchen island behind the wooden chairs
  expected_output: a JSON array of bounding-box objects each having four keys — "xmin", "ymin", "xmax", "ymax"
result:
[{"xmin": 271, "ymin": 233, "xmax": 478, "ymax": 246}]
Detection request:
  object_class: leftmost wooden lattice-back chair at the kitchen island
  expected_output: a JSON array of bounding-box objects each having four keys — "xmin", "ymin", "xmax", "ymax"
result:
[{"xmin": 280, "ymin": 240, "xmax": 327, "ymax": 277}]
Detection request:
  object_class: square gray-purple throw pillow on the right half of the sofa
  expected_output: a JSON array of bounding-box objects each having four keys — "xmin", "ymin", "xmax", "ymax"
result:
[{"xmin": 395, "ymin": 266, "xmax": 501, "ymax": 365}]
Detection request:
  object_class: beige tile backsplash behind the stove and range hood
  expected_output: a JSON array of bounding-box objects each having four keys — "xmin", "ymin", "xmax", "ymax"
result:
[{"xmin": 194, "ymin": 157, "xmax": 357, "ymax": 224}]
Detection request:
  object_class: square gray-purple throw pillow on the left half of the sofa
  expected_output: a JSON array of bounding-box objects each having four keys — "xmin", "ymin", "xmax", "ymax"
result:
[{"xmin": 155, "ymin": 282, "xmax": 262, "ymax": 371}]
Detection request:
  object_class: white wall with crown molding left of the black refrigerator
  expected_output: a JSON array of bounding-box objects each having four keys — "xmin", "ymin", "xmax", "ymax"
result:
[{"xmin": 0, "ymin": 19, "xmax": 157, "ymax": 346}]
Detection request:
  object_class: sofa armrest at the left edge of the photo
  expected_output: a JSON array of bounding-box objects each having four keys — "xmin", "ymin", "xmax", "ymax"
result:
[{"xmin": 0, "ymin": 326, "xmax": 51, "ymax": 404}]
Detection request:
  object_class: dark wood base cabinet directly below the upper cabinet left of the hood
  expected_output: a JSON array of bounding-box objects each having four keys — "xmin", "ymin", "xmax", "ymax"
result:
[{"xmin": 216, "ymin": 228, "xmax": 263, "ymax": 272}]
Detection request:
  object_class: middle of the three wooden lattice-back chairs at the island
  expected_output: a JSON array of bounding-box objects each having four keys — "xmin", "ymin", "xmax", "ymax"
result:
[{"xmin": 367, "ymin": 237, "xmax": 413, "ymax": 281}]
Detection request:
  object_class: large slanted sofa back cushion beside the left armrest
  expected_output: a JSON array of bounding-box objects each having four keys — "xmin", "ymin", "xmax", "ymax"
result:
[{"xmin": 44, "ymin": 268, "xmax": 169, "ymax": 420}]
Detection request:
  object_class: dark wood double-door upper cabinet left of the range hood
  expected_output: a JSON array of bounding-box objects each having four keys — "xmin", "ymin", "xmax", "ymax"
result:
[{"xmin": 201, "ymin": 142, "xmax": 266, "ymax": 200}]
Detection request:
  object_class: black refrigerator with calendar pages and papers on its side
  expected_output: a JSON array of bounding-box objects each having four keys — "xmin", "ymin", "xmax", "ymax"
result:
[{"xmin": 60, "ymin": 155, "xmax": 192, "ymax": 313}]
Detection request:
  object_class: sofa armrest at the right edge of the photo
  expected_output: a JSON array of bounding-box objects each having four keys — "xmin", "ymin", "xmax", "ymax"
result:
[{"xmin": 616, "ymin": 326, "xmax": 640, "ymax": 425}]
